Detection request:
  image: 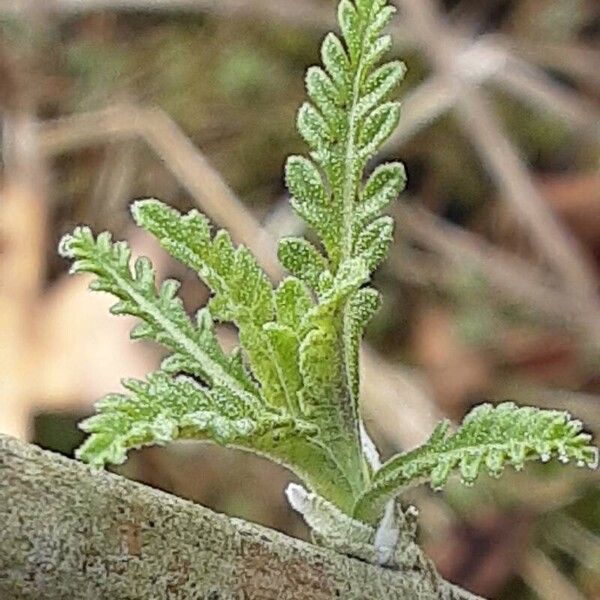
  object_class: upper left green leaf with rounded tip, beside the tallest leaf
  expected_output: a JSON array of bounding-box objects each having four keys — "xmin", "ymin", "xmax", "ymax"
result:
[{"xmin": 132, "ymin": 200, "xmax": 308, "ymax": 413}]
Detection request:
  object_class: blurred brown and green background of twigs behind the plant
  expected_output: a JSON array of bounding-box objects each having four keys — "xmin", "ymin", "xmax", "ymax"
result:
[{"xmin": 0, "ymin": 0, "xmax": 600, "ymax": 600}]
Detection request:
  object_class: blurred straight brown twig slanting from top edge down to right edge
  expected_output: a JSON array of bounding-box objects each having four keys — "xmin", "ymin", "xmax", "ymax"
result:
[{"xmin": 401, "ymin": 0, "xmax": 600, "ymax": 342}]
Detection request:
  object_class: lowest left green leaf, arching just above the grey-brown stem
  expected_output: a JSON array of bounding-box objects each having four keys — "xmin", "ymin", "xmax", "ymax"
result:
[{"xmin": 77, "ymin": 371, "xmax": 352, "ymax": 512}]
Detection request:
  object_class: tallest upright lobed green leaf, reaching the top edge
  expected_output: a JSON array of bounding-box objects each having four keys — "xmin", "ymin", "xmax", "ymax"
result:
[{"xmin": 279, "ymin": 0, "xmax": 405, "ymax": 478}]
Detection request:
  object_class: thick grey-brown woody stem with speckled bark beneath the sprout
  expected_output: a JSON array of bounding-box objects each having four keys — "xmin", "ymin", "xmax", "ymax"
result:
[{"xmin": 0, "ymin": 435, "xmax": 474, "ymax": 600}]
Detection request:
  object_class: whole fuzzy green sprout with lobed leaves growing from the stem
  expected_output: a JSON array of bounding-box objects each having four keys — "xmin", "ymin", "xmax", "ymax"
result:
[{"xmin": 60, "ymin": 0, "xmax": 597, "ymax": 564}]
